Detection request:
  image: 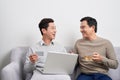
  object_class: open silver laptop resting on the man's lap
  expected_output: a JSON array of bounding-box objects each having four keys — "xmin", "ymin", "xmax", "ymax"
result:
[{"xmin": 37, "ymin": 52, "xmax": 78, "ymax": 74}]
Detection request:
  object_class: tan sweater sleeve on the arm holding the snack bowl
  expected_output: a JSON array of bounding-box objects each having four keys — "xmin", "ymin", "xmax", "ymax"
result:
[{"xmin": 102, "ymin": 41, "xmax": 118, "ymax": 69}]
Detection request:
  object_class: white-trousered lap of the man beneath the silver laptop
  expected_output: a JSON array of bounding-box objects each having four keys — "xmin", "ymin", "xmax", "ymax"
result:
[{"xmin": 31, "ymin": 70, "xmax": 71, "ymax": 80}]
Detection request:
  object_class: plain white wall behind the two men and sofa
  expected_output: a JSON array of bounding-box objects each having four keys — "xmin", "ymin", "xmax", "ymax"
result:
[{"xmin": 0, "ymin": 0, "xmax": 120, "ymax": 69}]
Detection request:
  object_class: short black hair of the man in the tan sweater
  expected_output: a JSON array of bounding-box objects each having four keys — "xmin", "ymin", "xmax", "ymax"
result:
[{"xmin": 80, "ymin": 17, "xmax": 97, "ymax": 33}]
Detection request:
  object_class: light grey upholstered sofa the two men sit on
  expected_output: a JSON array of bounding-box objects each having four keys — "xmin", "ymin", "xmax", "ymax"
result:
[{"xmin": 1, "ymin": 47, "xmax": 120, "ymax": 80}]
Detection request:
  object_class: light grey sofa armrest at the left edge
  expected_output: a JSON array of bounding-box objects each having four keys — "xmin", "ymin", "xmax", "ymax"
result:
[{"xmin": 1, "ymin": 62, "xmax": 22, "ymax": 80}]
